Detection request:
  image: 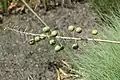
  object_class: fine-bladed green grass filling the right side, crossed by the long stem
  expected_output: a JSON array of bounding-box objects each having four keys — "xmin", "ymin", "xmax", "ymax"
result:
[{"xmin": 66, "ymin": 0, "xmax": 120, "ymax": 80}]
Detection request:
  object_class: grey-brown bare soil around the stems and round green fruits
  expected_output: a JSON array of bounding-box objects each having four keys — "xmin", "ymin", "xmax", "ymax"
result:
[{"xmin": 0, "ymin": 2, "xmax": 97, "ymax": 80}]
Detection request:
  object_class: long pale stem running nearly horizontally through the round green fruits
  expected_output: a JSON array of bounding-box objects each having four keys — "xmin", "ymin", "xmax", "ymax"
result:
[{"xmin": 4, "ymin": 27, "xmax": 120, "ymax": 44}]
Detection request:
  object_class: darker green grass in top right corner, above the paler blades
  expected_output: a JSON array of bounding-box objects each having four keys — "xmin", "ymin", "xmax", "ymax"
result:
[{"xmin": 90, "ymin": 0, "xmax": 120, "ymax": 28}]
